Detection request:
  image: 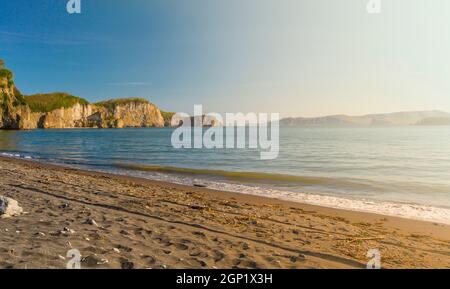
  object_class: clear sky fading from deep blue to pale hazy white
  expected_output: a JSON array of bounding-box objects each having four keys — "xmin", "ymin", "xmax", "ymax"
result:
[{"xmin": 0, "ymin": 0, "xmax": 450, "ymax": 117}]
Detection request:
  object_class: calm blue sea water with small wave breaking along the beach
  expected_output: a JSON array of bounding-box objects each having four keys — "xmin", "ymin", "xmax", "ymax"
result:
[{"xmin": 0, "ymin": 127, "xmax": 450, "ymax": 223}]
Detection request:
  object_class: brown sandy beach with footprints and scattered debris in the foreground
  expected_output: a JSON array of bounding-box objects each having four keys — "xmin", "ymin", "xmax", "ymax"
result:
[{"xmin": 0, "ymin": 158, "xmax": 450, "ymax": 269}]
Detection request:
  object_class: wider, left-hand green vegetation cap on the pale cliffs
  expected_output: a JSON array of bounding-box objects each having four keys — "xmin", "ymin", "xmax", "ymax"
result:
[{"xmin": 25, "ymin": 92, "xmax": 89, "ymax": 112}]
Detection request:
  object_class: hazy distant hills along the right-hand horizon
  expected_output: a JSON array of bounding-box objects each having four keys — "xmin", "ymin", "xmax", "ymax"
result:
[{"xmin": 280, "ymin": 110, "xmax": 450, "ymax": 127}]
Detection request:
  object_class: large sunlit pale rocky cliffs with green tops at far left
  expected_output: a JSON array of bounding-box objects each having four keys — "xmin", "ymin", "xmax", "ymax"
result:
[{"xmin": 0, "ymin": 61, "xmax": 164, "ymax": 129}]
